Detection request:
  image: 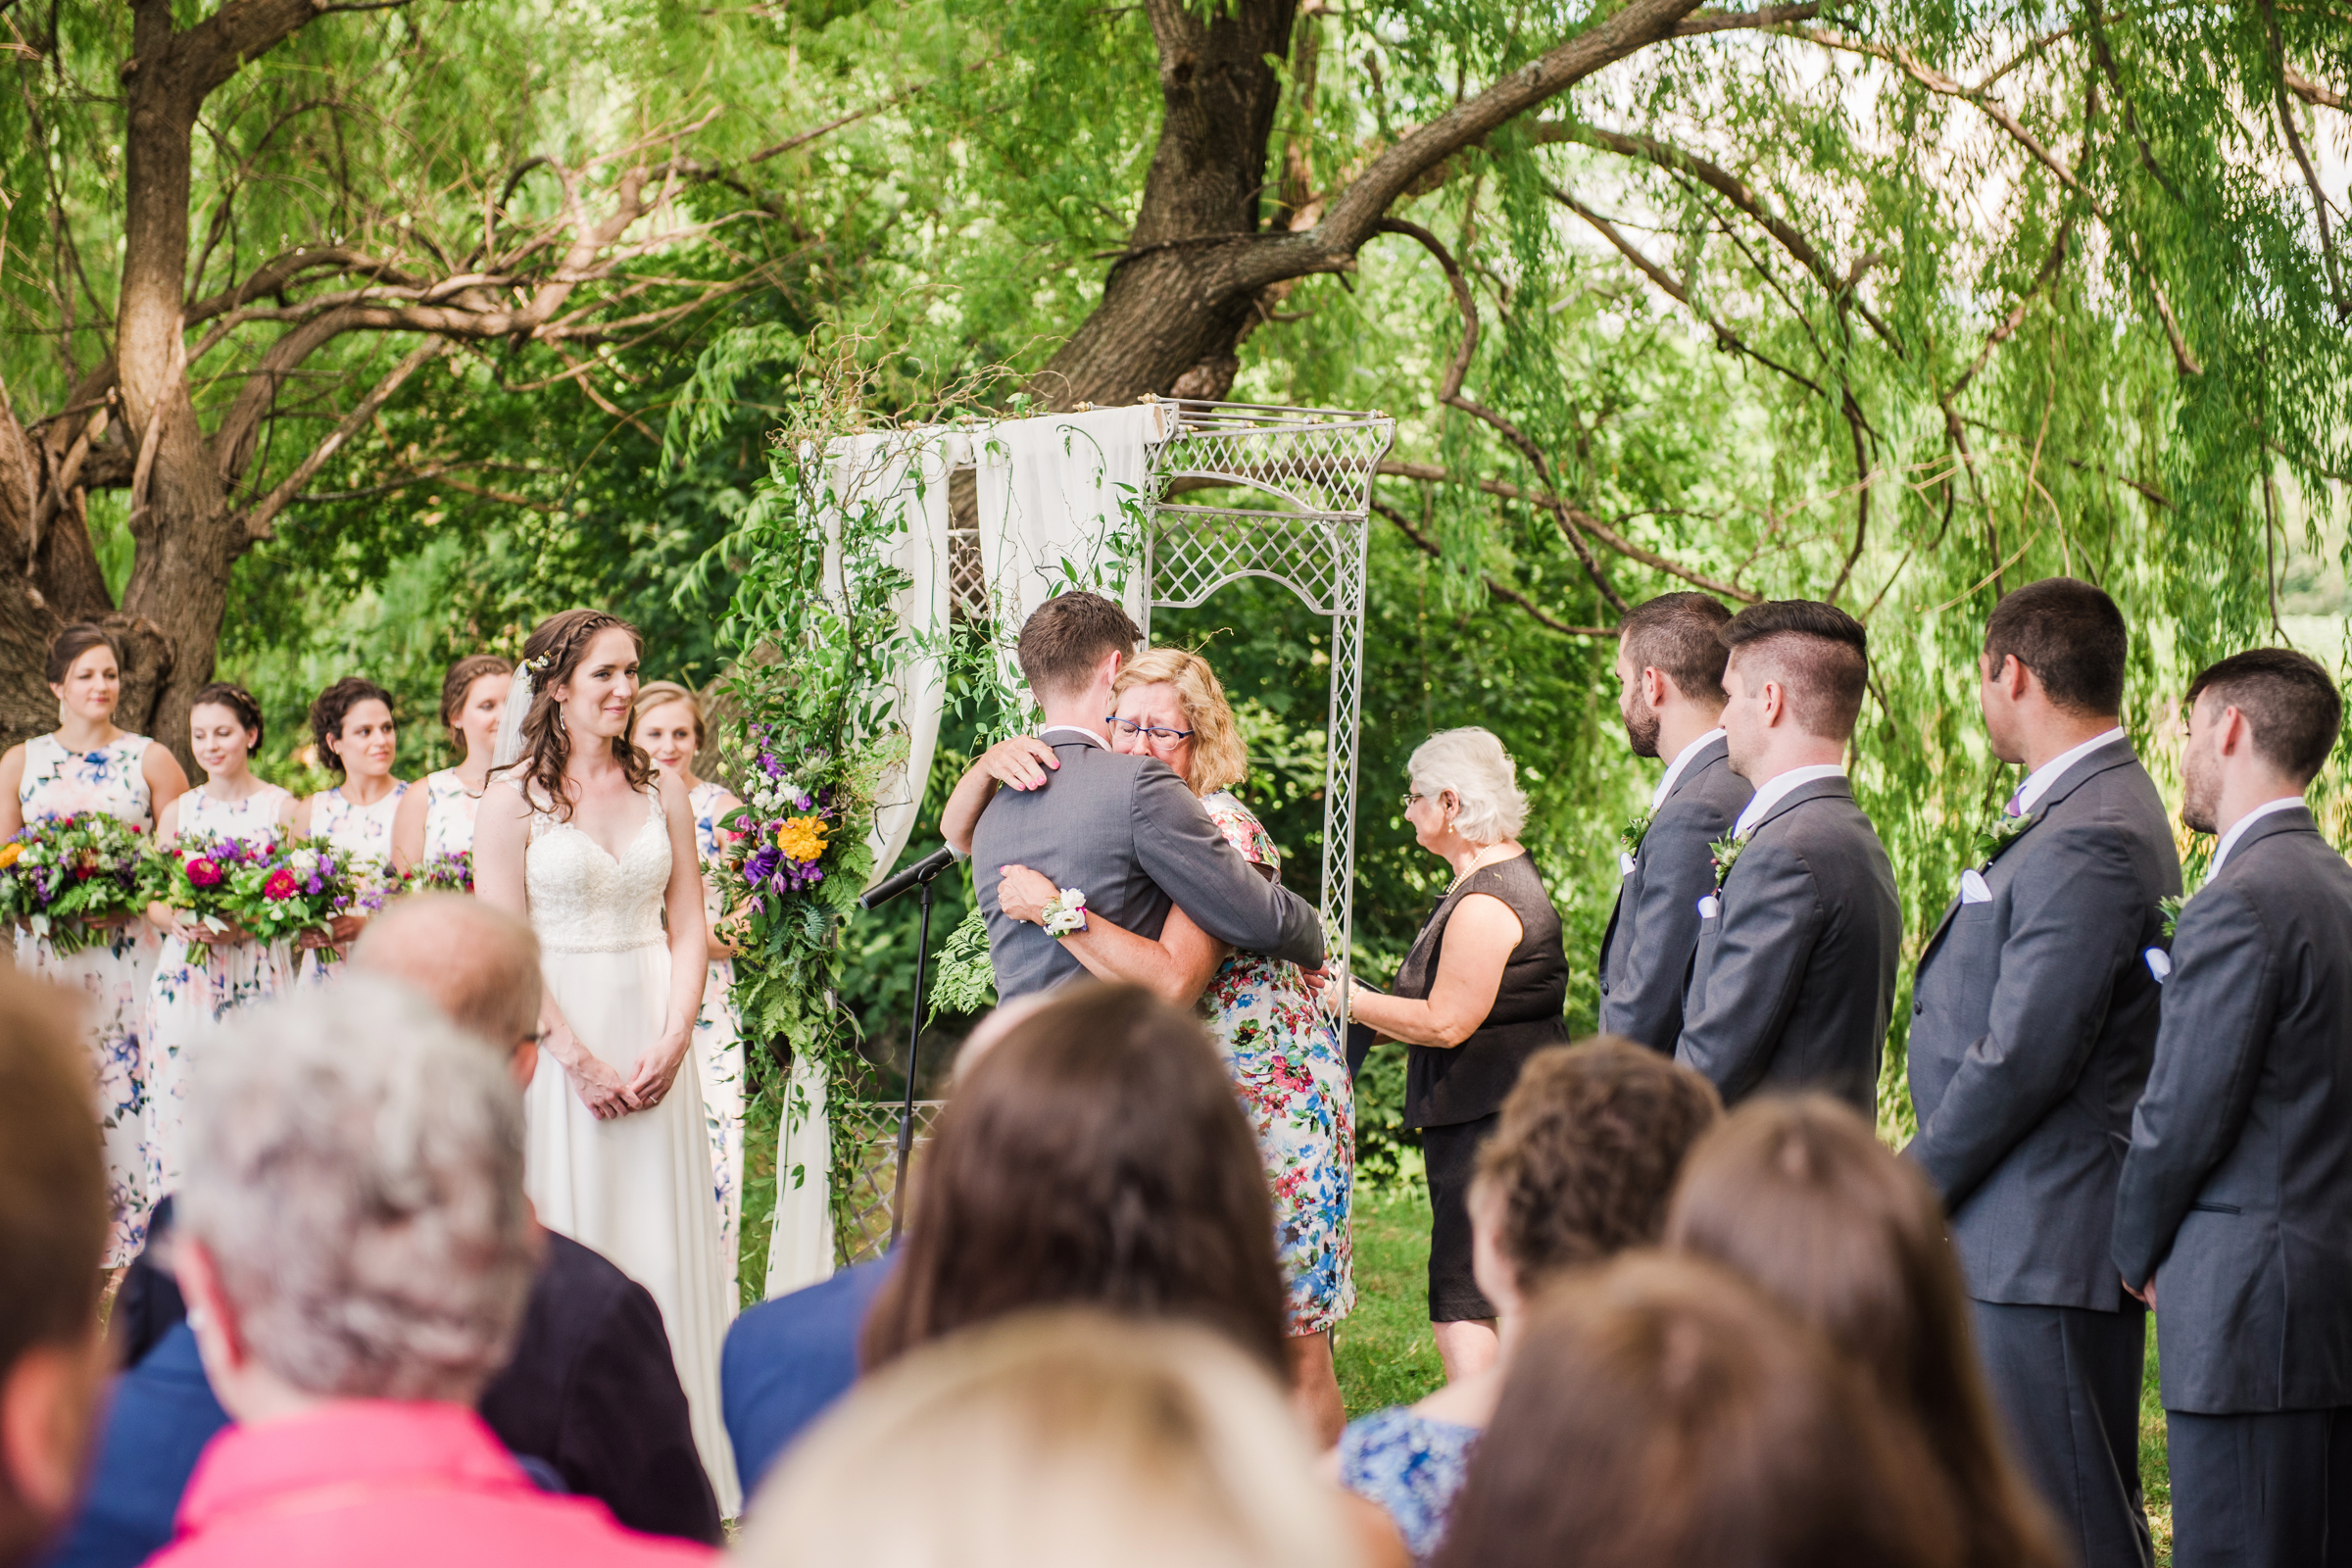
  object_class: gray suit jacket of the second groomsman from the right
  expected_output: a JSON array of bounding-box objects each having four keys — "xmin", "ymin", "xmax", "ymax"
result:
[{"xmin": 1905, "ymin": 741, "xmax": 2180, "ymax": 1312}]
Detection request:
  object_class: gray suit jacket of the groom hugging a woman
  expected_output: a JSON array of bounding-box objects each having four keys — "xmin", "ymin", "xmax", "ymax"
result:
[{"xmin": 971, "ymin": 741, "xmax": 1324, "ymax": 999}]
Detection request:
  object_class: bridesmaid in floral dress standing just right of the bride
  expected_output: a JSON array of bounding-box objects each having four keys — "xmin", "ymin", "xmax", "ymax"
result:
[{"xmin": 630, "ymin": 682, "xmax": 743, "ymax": 1304}]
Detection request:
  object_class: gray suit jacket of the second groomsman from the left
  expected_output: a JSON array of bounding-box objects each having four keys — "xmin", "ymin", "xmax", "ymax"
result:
[{"xmin": 1675, "ymin": 778, "xmax": 1903, "ymax": 1114}]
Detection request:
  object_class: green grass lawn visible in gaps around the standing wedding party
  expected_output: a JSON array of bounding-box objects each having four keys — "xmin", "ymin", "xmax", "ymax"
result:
[{"xmin": 1334, "ymin": 1190, "xmax": 2174, "ymax": 1568}]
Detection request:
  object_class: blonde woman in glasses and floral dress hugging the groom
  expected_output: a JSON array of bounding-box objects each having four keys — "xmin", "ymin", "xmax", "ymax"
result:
[{"xmin": 941, "ymin": 649, "xmax": 1354, "ymax": 1444}]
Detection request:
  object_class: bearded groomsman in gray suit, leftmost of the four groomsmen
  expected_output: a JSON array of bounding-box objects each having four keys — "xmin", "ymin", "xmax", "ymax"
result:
[{"xmin": 1599, "ymin": 592, "xmax": 1754, "ymax": 1054}]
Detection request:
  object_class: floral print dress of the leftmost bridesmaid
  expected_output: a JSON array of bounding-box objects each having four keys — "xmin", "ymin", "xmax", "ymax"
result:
[{"xmin": 17, "ymin": 733, "xmax": 158, "ymax": 1267}]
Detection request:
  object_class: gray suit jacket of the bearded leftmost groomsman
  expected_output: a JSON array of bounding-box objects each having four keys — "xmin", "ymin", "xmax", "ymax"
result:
[{"xmin": 1599, "ymin": 738, "xmax": 1754, "ymax": 1051}]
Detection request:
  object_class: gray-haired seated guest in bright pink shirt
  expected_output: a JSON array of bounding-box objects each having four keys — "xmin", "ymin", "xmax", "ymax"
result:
[{"xmin": 148, "ymin": 976, "xmax": 712, "ymax": 1568}]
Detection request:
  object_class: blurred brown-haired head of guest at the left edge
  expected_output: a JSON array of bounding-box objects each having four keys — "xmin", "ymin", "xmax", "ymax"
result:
[{"xmin": 0, "ymin": 968, "xmax": 106, "ymax": 1568}]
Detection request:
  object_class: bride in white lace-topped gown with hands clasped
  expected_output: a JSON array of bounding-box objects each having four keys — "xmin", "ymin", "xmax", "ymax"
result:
[{"xmin": 472, "ymin": 609, "xmax": 741, "ymax": 1519}]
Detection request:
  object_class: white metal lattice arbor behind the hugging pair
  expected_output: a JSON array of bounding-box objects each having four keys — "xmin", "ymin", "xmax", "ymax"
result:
[{"xmin": 1141, "ymin": 400, "xmax": 1397, "ymax": 959}]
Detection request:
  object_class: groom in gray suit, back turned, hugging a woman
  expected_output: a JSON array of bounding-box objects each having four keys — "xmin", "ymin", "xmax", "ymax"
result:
[{"xmin": 971, "ymin": 592, "xmax": 1324, "ymax": 1002}]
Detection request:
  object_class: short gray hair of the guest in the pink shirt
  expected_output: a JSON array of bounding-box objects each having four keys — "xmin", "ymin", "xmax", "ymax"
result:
[{"xmin": 178, "ymin": 976, "xmax": 539, "ymax": 1403}]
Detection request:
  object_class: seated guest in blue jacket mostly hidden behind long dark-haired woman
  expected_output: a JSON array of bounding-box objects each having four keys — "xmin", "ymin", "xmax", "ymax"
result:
[{"xmin": 719, "ymin": 992, "xmax": 1054, "ymax": 1493}]
